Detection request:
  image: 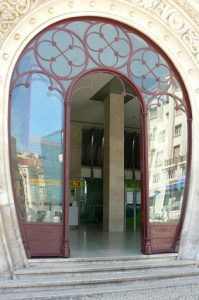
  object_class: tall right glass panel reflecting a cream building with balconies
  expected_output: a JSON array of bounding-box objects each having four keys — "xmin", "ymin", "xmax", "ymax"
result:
[{"xmin": 148, "ymin": 97, "xmax": 187, "ymax": 223}]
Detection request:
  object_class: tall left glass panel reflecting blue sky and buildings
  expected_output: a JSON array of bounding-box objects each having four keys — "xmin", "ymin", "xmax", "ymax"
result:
[{"xmin": 11, "ymin": 74, "xmax": 63, "ymax": 223}]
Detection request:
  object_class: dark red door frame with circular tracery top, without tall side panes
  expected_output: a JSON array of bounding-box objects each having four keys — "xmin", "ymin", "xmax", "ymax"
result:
[{"xmin": 9, "ymin": 17, "xmax": 191, "ymax": 257}]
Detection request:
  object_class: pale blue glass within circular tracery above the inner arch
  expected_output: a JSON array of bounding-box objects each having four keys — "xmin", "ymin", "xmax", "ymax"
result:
[{"xmin": 15, "ymin": 21, "xmax": 174, "ymax": 101}]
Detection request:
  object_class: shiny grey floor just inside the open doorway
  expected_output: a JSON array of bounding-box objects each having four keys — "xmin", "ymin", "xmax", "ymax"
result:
[{"xmin": 69, "ymin": 225, "xmax": 141, "ymax": 258}]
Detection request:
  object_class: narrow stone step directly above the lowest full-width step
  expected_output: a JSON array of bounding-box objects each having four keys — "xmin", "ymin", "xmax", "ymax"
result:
[{"xmin": 14, "ymin": 260, "xmax": 195, "ymax": 279}]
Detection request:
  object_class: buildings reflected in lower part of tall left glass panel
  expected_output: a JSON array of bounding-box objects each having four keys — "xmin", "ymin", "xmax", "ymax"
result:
[{"xmin": 12, "ymin": 131, "xmax": 62, "ymax": 222}]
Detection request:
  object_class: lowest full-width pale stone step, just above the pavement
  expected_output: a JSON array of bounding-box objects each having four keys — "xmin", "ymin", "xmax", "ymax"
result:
[{"xmin": 0, "ymin": 266, "xmax": 199, "ymax": 293}]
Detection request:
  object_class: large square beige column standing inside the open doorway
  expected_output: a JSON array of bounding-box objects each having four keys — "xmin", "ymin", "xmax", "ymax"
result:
[{"xmin": 103, "ymin": 94, "xmax": 124, "ymax": 232}]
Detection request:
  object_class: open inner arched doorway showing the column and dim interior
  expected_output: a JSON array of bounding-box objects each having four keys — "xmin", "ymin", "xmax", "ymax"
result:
[{"xmin": 69, "ymin": 72, "xmax": 142, "ymax": 257}]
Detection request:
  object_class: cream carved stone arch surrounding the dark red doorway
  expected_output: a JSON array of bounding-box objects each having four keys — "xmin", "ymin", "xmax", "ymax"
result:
[{"xmin": 0, "ymin": 0, "xmax": 199, "ymax": 275}]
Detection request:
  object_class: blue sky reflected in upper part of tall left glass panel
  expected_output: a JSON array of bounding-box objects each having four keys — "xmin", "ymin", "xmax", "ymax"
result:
[{"xmin": 12, "ymin": 76, "xmax": 63, "ymax": 153}]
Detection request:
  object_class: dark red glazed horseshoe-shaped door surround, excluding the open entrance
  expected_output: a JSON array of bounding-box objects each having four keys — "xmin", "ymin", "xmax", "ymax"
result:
[{"xmin": 10, "ymin": 18, "xmax": 190, "ymax": 256}]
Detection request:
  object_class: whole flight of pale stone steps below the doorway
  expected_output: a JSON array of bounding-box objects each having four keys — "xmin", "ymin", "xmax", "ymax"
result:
[{"xmin": 0, "ymin": 255, "xmax": 199, "ymax": 300}]
